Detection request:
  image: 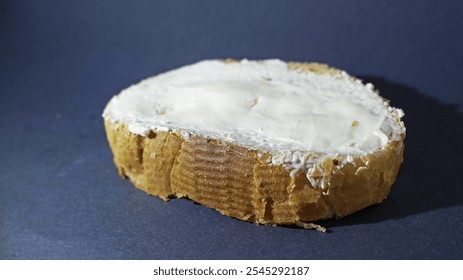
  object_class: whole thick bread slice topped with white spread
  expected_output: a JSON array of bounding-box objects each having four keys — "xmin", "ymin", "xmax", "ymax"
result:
[{"xmin": 103, "ymin": 60, "xmax": 405, "ymax": 229}]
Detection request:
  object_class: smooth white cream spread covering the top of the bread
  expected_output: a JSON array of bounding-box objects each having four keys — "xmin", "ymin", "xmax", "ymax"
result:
[{"xmin": 103, "ymin": 60, "xmax": 405, "ymax": 186}]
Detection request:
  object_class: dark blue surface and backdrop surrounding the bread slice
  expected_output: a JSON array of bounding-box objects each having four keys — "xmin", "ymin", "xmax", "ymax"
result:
[{"xmin": 0, "ymin": 0, "xmax": 463, "ymax": 259}]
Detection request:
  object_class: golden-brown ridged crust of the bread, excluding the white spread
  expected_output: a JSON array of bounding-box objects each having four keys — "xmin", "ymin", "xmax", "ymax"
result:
[{"xmin": 104, "ymin": 60, "xmax": 405, "ymax": 226}]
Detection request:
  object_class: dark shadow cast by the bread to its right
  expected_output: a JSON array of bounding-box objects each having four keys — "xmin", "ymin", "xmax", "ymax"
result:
[{"xmin": 321, "ymin": 76, "xmax": 463, "ymax": 228}]
